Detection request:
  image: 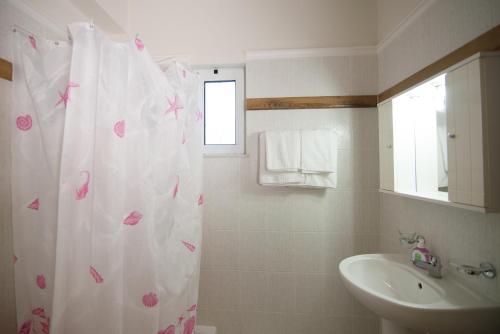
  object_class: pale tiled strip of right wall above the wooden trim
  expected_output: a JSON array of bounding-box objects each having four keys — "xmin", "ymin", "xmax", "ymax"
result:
[{"xmin": 378, "ymin": 0, "xmax": 500, "ymax": 92}]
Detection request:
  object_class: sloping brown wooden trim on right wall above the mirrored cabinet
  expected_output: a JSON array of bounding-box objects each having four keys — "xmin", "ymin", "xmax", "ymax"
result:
[{"xmin": 378, "ymin": 25, "xmax": 500, "ymax": 103}]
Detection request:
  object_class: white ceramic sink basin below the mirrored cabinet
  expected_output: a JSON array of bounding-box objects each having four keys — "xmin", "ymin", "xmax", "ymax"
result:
[{"xmin": 339, "ymin": 254, "xmax": 500, "ymax": 334}]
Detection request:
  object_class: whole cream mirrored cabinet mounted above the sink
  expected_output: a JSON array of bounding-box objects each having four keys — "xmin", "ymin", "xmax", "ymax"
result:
[{"xmin": 378, "ymin": 52, "xmax": 500, "ymax": 211}]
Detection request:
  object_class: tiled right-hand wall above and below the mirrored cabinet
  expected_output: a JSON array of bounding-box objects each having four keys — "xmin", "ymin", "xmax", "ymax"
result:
[{"xmin": 379, "ymin": 0, "xmax": 500, "ymax": 320}]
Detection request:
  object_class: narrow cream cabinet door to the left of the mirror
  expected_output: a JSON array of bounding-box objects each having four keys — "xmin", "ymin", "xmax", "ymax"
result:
[{"xmin": 378, "ymin": 101, "xmax": 394, "ymax": 191}]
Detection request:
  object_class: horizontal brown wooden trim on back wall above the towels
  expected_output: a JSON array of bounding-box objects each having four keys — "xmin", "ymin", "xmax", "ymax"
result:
[{"xmin": 246, "ymin": 95, "xmax": 377, "ymax": 110}]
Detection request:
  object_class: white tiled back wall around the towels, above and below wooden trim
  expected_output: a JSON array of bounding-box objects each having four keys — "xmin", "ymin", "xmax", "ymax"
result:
[{"xmin": 199, "ymin": 55, "xmax": 379, "ymax": 334}]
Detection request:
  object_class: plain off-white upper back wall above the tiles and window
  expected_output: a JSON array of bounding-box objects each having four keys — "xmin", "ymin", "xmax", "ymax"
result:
[{"xmin": 129, "ymin": 0, "xmax": 377, "ymax": 64}]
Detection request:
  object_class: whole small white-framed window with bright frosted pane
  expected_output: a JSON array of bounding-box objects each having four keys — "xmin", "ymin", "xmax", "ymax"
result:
[{"xmin": 198, "ymin": 67, "xmax": 245, "ymax": 154}]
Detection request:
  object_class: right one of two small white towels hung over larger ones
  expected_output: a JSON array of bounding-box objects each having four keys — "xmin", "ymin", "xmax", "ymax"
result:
[{"xmin": 300, "ymin": 130, "xmax": 337, "ymax": 173}]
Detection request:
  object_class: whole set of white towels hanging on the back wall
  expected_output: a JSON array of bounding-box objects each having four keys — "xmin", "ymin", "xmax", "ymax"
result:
[{"xmin": 259, "ymin": 130, "xmax": 337, "ymax": 188}]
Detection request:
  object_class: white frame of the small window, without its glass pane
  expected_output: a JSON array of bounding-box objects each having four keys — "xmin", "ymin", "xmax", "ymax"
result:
[{"xmin": 197, "ymin": 66, "xmax": 245, "ymax": 155}]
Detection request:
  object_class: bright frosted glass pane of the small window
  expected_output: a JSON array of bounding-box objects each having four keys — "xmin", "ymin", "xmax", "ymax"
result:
[{"xmin": 205, "ymin": 81, "xmax": 236, "ymax": 145}]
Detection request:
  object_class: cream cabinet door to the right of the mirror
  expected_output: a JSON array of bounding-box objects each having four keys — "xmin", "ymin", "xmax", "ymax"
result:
[{"xmin": 446, "ymin": 60, "xmax": 485, "ymax": 207}]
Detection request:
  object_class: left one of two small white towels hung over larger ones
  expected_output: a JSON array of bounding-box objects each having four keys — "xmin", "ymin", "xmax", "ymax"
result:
[{"xmin": 265, "ymin": 130, "xmax": 300, "ymax": 172}]
